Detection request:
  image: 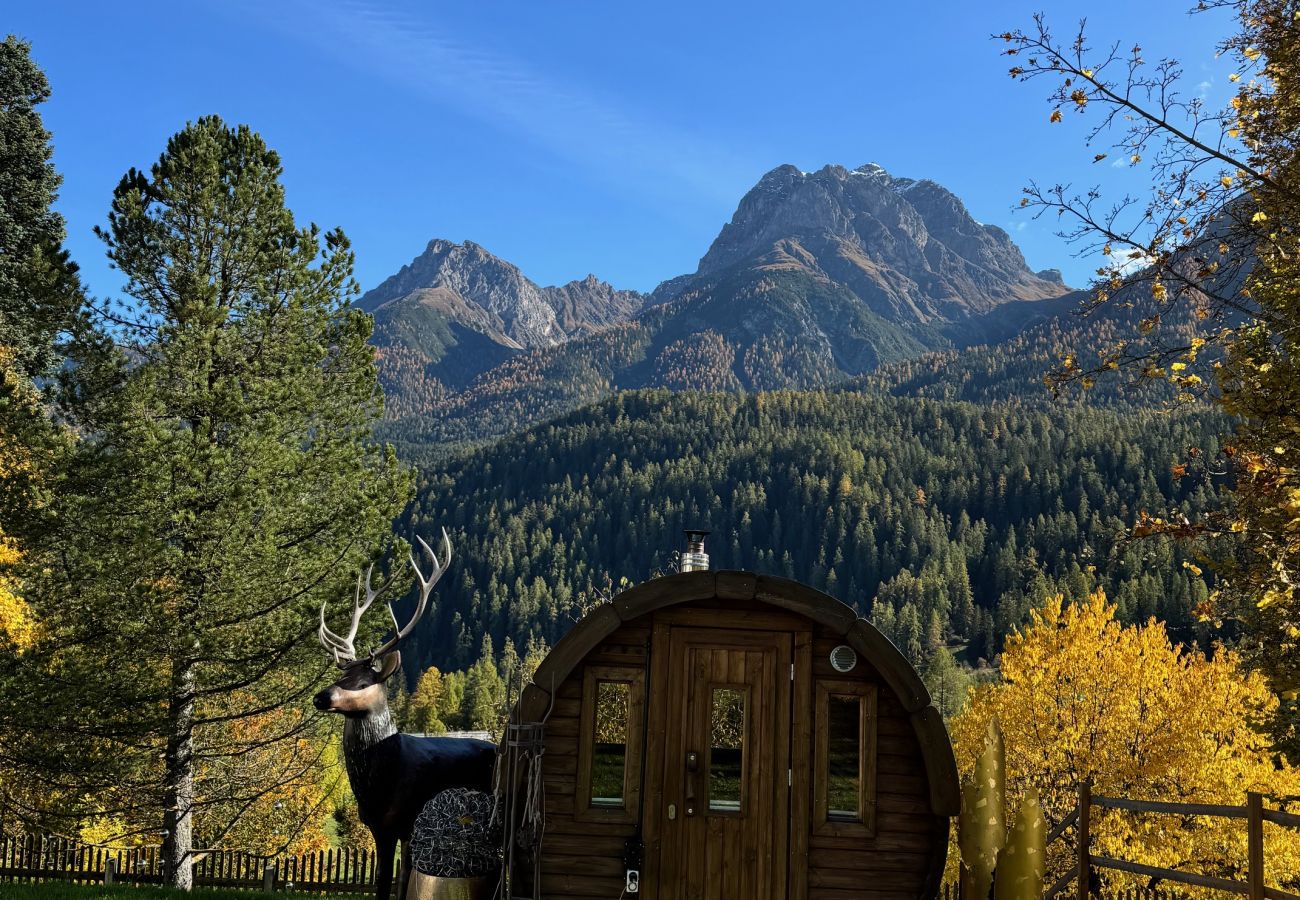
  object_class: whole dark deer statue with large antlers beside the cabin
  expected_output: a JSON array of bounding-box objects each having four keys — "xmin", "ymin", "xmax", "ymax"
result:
[{"xmin": 312, "ymin": 529, "xmax": 497, "ymax": 900}]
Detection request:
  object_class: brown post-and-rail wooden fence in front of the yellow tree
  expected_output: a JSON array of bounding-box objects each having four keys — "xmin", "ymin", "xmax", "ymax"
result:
[{"xmin": 1043, "ymin": 784, "xmax": 1300, "ymax": 900}]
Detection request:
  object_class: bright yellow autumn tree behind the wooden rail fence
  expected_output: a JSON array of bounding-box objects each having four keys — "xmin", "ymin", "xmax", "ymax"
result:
[{"xmin": 952, "ymin": 592, "xmax": 1300, "ymax": 890}]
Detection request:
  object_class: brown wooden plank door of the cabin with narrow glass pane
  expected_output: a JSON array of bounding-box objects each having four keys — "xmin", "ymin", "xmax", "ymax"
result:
[{"xmin": 647, "ymin": 627, "xmax": 793, "ymax": 900}]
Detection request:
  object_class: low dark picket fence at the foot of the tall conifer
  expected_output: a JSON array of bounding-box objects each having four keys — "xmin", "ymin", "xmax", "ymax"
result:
[{"xmin": 0, "ymin": 835, "xmax": 384, "ymax": 893}]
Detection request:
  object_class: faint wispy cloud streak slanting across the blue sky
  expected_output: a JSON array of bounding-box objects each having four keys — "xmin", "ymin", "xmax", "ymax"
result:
[{"xmin": 233, "ymin": 0, "xmax": 753, "ymax": 200}]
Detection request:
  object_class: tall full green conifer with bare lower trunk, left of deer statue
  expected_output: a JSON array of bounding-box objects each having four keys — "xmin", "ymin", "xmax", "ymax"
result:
[{"xmin": 2, "ymin": 117, "xmax": 410, "ymax": 888}]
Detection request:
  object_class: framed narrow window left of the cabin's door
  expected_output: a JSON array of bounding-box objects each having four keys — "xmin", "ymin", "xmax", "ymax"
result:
[{"xmin": 576, "ymin": 666, "xmax": 645, "ymax": 822}]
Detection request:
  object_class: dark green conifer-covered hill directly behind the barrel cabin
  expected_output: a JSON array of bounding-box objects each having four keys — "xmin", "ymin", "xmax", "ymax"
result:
[{"xmin": 402, "ymin": 391, "xmax": 1226, "ymax": 671}]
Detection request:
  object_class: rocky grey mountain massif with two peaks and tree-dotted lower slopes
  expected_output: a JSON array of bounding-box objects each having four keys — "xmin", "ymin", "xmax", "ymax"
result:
[{"xmin": 363, "ymin": 165, "xmax": 1070, "ymax": 457}]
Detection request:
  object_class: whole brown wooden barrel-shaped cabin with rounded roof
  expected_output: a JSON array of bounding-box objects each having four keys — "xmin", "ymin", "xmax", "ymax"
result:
[{"xmin": 506, "ymin": 571, "xmax": 959, "ymax": 900}]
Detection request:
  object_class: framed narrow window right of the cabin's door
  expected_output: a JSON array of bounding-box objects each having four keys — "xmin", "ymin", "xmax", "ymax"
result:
[{"xmin": 813, "ymin": 680, "xmax": 876, "ymax": 836}]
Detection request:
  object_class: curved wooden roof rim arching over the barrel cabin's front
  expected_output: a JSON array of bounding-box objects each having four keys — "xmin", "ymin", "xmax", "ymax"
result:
[{"xmin": 520, "ymin": 571, "xmax": 961, "ymax": 815}]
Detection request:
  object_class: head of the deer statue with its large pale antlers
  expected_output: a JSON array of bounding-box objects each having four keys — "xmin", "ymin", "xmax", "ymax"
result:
[{"xmin": 312, "ymin": 528, "xmax": 451, "ymax": 718}]
